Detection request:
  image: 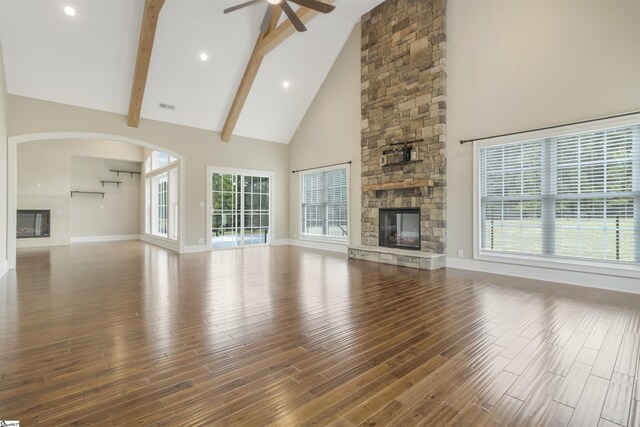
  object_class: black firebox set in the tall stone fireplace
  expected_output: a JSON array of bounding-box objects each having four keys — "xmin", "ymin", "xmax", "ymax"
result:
[{"xmin": 378, "ymin": 208, "xmax": 420, "ymax": 250}]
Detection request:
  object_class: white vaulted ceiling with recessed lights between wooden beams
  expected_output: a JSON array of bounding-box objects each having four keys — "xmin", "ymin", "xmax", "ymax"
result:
[{"xmin": 0, "ymin": 0, "xmax": 382, "ymax": 143}]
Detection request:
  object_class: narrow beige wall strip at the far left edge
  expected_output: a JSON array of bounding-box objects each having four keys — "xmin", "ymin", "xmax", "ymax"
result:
[{"xmin": 0, "ymin": 38, "xmax": 7, "ymax": 270}]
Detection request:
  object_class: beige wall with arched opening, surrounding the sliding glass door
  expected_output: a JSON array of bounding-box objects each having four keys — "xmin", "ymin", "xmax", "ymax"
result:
[{"xmin": 8, "ymin": 95, "xmax": 288, "ymax": 246}]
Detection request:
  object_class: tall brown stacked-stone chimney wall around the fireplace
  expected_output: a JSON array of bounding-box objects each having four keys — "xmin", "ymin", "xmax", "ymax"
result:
[{"xmin": 361, "ymin": 0, "xmax": 446, "ymax": 253}]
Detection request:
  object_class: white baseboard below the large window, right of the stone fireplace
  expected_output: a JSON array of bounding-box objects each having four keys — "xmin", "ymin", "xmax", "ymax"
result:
[{"xmin": 446, "ymin": 257, "xmax": 640, "ymax": 294}]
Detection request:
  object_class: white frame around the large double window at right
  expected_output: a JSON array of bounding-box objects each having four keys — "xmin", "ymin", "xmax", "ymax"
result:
[{"xmin": 472, "ymin": 114, "xmax": 640, "ymax": 278}]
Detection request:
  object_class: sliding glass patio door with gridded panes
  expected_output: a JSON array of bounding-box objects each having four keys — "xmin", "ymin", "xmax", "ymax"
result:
[{"xmin": 211, "ymin": 172, "xmax": 271, "ymax": 249}]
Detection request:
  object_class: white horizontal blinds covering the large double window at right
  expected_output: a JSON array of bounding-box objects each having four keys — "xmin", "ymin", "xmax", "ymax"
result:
[{"xmin": 479, "ymin": 125, "xmax": 640, "ymax": 262}]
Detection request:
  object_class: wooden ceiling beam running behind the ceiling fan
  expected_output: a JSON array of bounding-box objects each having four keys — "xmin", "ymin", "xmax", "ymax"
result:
[{"xmin": 221, "ymin": 0, "xmax": 334, "ymax": 142}]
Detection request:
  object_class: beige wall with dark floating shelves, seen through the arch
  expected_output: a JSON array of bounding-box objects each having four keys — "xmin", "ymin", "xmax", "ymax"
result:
[{"xmin": 17, "ymin": 139, "xmax": 143, "ymax": 247}]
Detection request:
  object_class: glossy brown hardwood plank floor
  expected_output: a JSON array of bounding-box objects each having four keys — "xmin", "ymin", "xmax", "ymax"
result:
[{"xmin": 0, "ymin": 242, "xmax": 640, "ymax": 427}]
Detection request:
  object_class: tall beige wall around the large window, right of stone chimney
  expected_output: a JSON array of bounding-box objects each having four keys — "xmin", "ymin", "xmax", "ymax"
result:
[{"xmin": 447, "ymin": 0, "xmax": 640, "ymax": 258}]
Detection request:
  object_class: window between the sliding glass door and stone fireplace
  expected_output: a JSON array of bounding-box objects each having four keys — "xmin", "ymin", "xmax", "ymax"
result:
[{"xmin": 301, "ymin": 167, "xmax": 348, "ymax": 239}]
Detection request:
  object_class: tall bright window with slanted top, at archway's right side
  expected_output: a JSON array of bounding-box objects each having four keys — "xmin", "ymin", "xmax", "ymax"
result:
[{"xmin": 145, "ymin": 151, "xmax": 178, "ymax": 240}]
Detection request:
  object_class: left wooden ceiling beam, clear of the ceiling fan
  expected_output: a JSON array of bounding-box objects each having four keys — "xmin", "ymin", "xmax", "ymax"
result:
[{"xmin": 127, "ymin": 0, "xmax": 165, "ymax": 128}]
